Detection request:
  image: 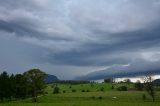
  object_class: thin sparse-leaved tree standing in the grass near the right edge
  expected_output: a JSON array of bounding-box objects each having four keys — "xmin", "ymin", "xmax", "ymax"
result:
[{"xmin": 144, "ymin": 75, "xmax": 155, "ymax": 102}]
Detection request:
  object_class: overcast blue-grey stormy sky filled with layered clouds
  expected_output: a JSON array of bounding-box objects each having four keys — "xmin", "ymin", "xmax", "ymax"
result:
[{"xmin": 0, "ymin": 0, "xmax": 160, "ymax": 79}]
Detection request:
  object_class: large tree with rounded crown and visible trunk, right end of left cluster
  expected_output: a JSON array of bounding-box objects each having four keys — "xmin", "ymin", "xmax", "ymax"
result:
[{"xmin": 24, "ymin": 69, "xmax": 46, "ymax": 102}]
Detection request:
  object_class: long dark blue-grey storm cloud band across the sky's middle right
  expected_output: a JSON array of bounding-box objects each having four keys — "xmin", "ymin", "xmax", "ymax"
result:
[{"xmin": 47, "ymin": 27, "xmax": 160, "ymax": 66}]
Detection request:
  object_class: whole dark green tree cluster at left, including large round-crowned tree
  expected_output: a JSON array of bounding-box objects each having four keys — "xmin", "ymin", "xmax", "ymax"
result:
[{"xmin": 0, "ymin": 69, "xmax": 46, "ymax": 102}]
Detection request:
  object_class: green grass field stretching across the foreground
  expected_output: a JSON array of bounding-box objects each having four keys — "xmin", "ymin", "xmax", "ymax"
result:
[{"xmin": 0, "ymin": 83, "xmax": 160, "ymax": 106}]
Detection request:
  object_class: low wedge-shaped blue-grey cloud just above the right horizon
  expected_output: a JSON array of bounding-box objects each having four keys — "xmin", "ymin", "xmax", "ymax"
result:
[{"xmin": 76, "ymin": 60, "xmax": 160, "ymax": 80}]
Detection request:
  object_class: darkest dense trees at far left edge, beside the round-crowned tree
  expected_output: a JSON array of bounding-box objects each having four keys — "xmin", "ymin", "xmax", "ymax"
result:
[{"xmin": 0, "ymin": 72, "xmax": 28, "ymax": 102}]
